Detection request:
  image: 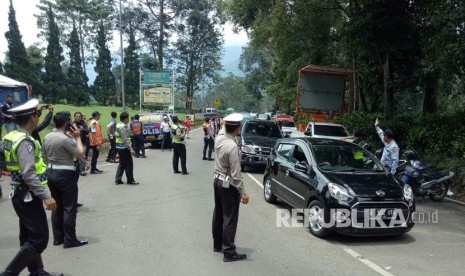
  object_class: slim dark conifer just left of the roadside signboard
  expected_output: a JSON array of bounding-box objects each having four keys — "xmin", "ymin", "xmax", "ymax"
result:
[{"xmin": 124, "ymin": 24, "xmax": 139, "ymax": 107}]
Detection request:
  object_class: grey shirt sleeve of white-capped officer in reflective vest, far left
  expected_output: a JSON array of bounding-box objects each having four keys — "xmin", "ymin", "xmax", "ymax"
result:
[{"xmin": 16, "ymin": 127, "xmax": 50, "ymax": 200}]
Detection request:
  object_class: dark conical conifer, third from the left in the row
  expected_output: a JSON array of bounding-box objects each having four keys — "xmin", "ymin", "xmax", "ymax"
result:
[{"xmin": 67, "ymin": 21, "xmax": 89, "ymax": 106}]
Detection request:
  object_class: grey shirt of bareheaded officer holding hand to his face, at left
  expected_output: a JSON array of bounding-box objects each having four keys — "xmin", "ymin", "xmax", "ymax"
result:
[{"xmin": 43, "ymin": 129, "xmax": 79, "ymax": 166}]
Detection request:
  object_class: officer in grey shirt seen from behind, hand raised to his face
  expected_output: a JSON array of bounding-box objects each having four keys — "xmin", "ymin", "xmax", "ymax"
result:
[{"xmin": 44, "ymin": 111, "xmax": 87, "ymax": 248}]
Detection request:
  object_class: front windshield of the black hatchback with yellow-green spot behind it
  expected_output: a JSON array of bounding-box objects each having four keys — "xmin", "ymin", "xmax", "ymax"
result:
[{"xmin": 313, "ymin": 144, "xmax": 384, "ymax": 172}]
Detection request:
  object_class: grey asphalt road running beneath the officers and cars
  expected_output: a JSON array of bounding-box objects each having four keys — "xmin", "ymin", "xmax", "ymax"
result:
[{"xmin": 0, "ymin": 131, "xmax": 465, "ymax": 276}]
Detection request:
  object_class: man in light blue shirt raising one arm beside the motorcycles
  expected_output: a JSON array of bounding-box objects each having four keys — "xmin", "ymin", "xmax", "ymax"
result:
[{"xmin": 375, "ymin": 118, "xmax": 399, "ymax": 174}]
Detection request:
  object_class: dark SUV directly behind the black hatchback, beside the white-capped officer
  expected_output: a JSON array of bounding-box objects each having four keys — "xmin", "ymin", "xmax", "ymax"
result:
[{"xmin": 241, "ymin": 120, "xmax": 283, "ymax": 171}]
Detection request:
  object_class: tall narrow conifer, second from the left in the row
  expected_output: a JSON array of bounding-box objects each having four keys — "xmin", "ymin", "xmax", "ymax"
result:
[{"xmin": 42, "ymin": 6, "xmax": 66, "ymax": 103}]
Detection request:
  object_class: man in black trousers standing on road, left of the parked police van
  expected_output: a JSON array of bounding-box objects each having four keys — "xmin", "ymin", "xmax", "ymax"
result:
[{"xmin": 115, "ymin": 112, "xmax": 139, "ymax": 185}]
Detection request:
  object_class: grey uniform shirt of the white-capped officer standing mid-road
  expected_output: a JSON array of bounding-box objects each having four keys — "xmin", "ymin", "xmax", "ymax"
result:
[{"xmin": 215, "ymin": 132, "xmax": 245, "ymax": 194}]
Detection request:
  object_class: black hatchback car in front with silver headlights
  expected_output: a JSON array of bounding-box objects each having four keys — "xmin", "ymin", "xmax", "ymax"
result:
[{"xmin": 263, "ymin": 138, "xmax": 415, "ymax": 237}]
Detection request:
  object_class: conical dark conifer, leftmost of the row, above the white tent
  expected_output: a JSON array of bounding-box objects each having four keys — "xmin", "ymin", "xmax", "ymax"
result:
[{"xmin": 5, "ymin": 0, "xmax": 33, "ymax": 84}]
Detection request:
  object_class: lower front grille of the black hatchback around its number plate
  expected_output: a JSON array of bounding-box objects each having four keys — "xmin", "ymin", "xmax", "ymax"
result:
[{"xmin": 352, "ymin": 201, "xmax": 410, "ymax": 228}]
